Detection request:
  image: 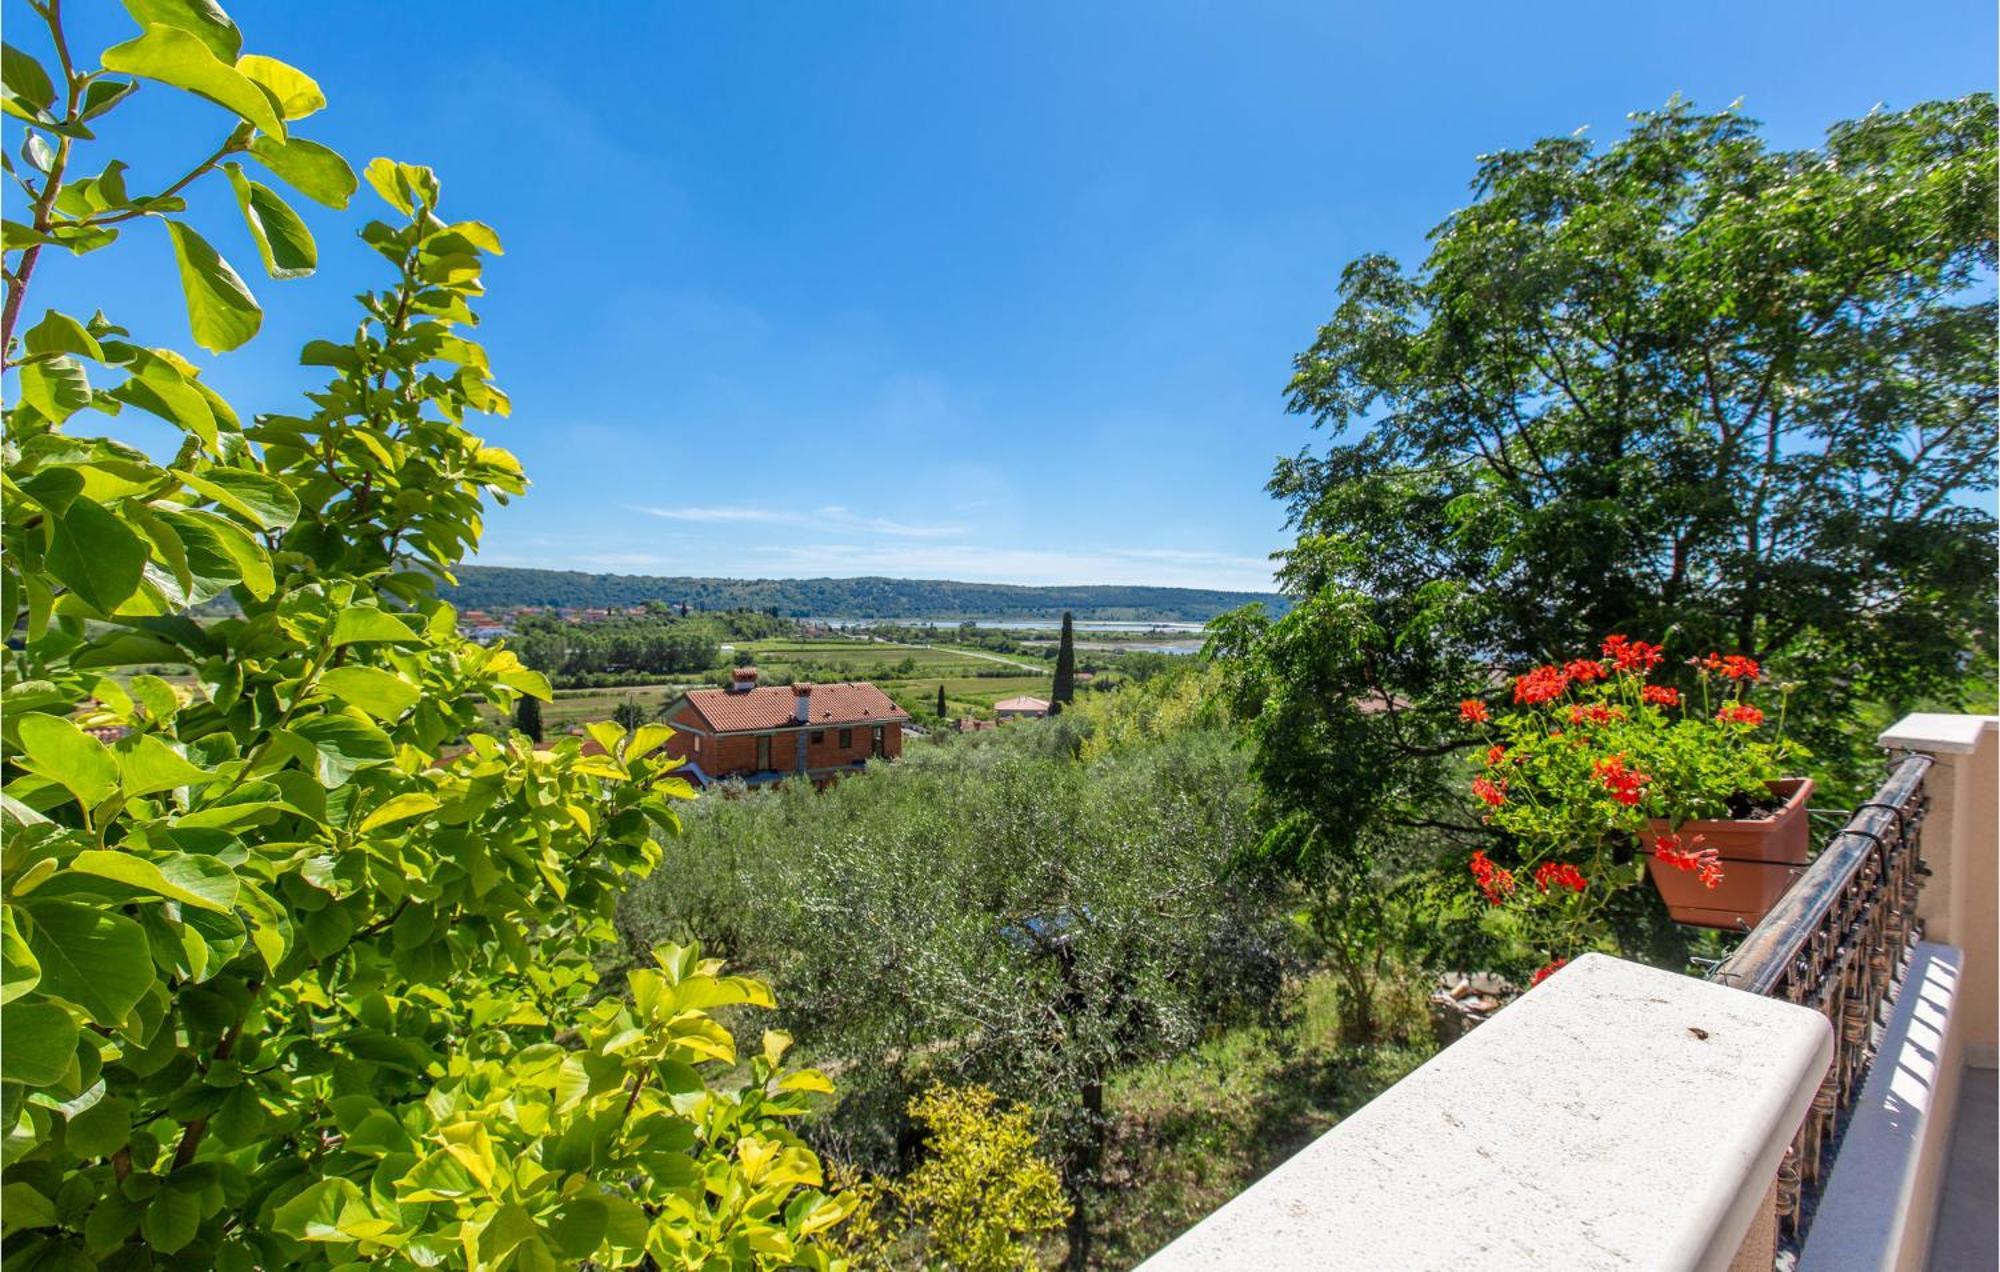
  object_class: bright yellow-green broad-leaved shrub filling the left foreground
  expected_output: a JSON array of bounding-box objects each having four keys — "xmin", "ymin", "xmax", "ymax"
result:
[{"xmin": 0, "ymin": 0, "xmax": 850, "ymax": 1268}]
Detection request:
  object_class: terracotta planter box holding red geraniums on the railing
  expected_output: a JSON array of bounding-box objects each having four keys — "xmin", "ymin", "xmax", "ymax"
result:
[{"xmin": 1644, "ymin": 778, "xmax": 1812, "ymax": 932}]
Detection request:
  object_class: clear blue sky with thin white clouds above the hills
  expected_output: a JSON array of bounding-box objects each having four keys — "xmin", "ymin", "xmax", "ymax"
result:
[{"xmin": 19, "ymin": 0, "xmax": 1996, "ymax": 588}]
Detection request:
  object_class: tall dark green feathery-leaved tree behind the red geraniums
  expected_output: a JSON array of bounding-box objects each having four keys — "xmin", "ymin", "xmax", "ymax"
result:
[{"xmin": 1216, "ymin": 94, "xmax": 1996, "ymax": 886}]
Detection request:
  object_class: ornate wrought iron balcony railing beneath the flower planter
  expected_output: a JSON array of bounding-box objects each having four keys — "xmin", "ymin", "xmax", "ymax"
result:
[{"xmin": 1712, "ymin": 756, "xmax": 1930, "ymax": 1248}]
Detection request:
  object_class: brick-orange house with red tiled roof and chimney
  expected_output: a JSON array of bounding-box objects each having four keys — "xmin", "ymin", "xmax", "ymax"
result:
[{"xmin": 666, "ymin": 666, "xmax": 910, "ymax": 784}]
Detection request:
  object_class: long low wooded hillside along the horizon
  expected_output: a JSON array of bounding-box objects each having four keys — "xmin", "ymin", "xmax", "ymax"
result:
[{"xmin": 444, "ymin": 566, "xmax": 1286, "ymax": 622}]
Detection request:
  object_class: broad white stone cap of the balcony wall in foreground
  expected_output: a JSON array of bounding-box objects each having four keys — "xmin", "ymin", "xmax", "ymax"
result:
[{"xmin": 1144, "ymin": 954, "xmax": 1834, "ymax": 1272}]
